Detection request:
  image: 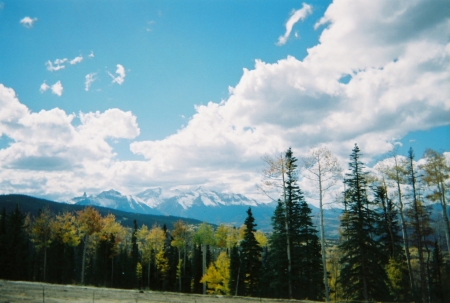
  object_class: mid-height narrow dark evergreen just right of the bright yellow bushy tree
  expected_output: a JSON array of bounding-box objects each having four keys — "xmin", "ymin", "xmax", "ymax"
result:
[{"xmin": 241, "ymin": 207, "xmax": 262, "ymax": 296}]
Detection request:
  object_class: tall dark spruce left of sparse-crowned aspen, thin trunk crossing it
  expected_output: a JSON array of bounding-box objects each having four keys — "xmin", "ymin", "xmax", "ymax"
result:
[{"xmin": 264, "ymin": 149, "xmax": 324, "ymax": 300}]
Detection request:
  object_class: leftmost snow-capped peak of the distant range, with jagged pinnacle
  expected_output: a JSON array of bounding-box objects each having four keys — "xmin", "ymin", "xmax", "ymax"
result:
[{"xmin": 68, "ymin": 189, "xmax": 161, "ymax": 215}]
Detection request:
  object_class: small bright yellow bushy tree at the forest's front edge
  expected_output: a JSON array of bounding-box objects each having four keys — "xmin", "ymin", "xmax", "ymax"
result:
[{"xmin": 200, "ymin": 252, "xmax": 230, "ymax": 295}]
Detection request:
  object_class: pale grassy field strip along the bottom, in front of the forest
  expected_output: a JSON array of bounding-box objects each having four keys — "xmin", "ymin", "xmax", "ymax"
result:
[{"xmin": 0, "ymin": 280, "xmax": 318, "ymax": 303}]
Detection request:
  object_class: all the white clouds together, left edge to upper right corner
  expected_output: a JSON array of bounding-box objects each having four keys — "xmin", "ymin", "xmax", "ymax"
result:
[{"xmin": 0, "ymin": 0, "xmax": 450, "ymax": 204}]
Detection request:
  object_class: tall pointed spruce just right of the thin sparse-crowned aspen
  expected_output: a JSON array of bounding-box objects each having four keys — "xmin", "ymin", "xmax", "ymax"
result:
[{"xmin": 339, "ymin": 144, "xmax": 388, "ymax": 301}]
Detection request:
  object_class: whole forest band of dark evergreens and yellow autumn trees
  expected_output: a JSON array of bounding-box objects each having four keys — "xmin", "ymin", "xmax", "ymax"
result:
[{"xmin": 0, "ymin": 145, "xmax": 450, "ymax": 303}]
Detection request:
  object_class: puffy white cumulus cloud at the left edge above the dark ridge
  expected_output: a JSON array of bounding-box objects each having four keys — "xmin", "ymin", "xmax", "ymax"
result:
[{"xmin": 0, "ymin": 84, "xmax": 139, "ymax": 198}]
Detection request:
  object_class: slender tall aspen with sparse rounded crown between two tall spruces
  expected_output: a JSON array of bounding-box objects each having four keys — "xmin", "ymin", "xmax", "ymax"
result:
[{"xmin": 303, "ymin": 147, "xmax": 342, "ymax": 302}]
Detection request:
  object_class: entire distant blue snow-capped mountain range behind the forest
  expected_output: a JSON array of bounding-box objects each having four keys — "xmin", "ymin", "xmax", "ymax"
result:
[{"xmin": 67, "ymin": 187, "xmax": 340, "ymax": 238}]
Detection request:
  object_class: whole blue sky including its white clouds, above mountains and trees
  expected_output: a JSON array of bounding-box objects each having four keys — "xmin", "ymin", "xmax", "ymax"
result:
[{"xmin": 0, "ymin": 0, "xmax": 450, "ymax": 204}]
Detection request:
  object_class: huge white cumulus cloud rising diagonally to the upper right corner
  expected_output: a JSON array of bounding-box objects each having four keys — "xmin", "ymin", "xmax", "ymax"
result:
[{"xmin": 129, "ymin": 0, "xmax": 450, "ymax": 198}]
